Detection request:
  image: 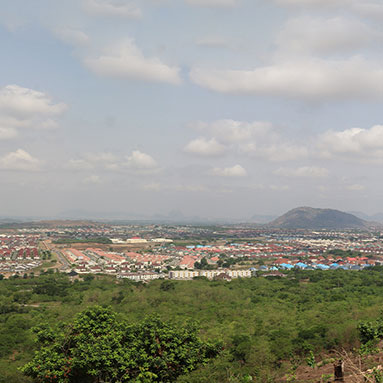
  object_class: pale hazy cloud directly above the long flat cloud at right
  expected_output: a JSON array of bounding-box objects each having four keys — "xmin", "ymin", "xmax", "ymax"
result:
[{"xmin": 276, "ymin": 16, "xmax": 378, "ymax": 55}]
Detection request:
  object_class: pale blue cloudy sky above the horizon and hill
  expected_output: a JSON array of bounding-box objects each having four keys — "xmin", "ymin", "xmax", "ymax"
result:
[{"xmin": 0, "ymin": 0, "xmax": 383, "ymax": 220}]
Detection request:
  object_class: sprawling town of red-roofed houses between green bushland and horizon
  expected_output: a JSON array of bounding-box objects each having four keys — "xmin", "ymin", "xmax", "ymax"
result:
[{"xmin": 0, "ymin": 221, "xmax": 383, "ymax": 281}]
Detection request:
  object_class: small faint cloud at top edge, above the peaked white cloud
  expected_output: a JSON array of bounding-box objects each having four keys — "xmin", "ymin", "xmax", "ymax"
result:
[{"xmin": 84, "ymin": 0, "xmax": 142, "ymax": 19}]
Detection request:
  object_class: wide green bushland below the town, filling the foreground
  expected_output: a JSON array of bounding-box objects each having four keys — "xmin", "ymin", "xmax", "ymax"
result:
[{"xmin": 0, "ymin": 267, "xmax": 383, "ymax": 383}]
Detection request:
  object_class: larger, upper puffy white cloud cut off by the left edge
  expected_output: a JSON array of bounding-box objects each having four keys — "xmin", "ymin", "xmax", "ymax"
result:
[{"xmin": 0, "ymin": 85, "xmax": 66, "ymax": 140}]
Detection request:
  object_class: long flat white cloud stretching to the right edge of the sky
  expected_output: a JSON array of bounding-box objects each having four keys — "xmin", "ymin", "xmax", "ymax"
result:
[{"xmin": 190, "ymin": 57, "xmax": 383, "ymax": 101}]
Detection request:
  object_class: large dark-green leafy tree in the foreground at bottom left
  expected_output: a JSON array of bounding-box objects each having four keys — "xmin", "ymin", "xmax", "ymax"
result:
[{"xmin": 21, "ymin": 306, "xmax": 219, "ymax": 383}]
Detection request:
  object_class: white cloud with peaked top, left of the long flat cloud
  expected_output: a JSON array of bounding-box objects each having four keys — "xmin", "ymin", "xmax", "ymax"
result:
[{"xmin": 84, "ymin": 39, "xmax": 181, "ymax": 85}]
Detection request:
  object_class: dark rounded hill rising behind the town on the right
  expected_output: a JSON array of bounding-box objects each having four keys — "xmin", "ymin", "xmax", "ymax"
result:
[{"xmin": 268, "ymin": 207, "xmax": 370, "ymax": 230}]
